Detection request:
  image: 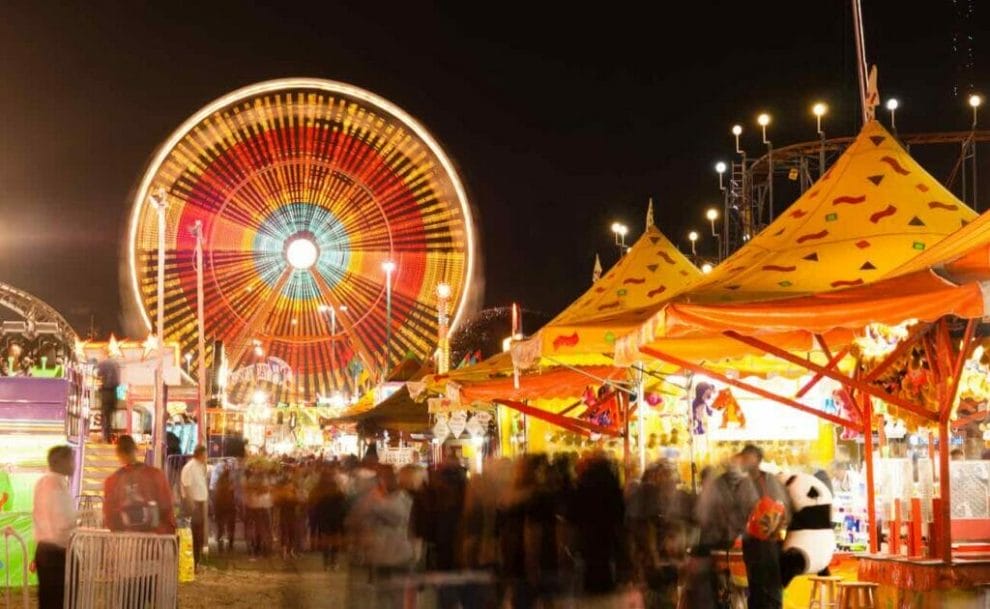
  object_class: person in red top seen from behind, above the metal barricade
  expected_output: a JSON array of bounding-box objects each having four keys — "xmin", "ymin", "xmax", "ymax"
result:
[{"xmin": 103, "ymin": 435, "xmax": 175, "ymax": 535}]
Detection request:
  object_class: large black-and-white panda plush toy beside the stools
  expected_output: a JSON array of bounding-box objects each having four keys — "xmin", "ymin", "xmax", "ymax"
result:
[{"xmin": 780, "ymin": 473, "xmax": 835, "ymax": 587}]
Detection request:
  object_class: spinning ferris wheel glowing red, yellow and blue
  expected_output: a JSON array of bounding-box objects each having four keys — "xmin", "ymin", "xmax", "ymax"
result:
[{"xmin": 128, "ymin": 78, "xmax": 474, "ymax": 402}]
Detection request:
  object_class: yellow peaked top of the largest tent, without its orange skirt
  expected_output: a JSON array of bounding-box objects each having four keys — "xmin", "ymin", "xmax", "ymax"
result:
[{"xmin": 682, "ymin": 120, "xmax": 976, "ymax": 302}]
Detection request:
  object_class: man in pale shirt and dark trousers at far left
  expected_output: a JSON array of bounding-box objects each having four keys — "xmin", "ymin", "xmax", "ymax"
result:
[{"xmin": 33, "ymin": 445, "xmax": 76, "ymax": 609}]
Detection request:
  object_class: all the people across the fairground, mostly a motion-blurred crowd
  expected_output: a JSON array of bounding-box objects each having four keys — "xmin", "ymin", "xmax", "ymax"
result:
[{"xmin": 35, "ymin": 436, "xmax": 808, "ymax": 609}]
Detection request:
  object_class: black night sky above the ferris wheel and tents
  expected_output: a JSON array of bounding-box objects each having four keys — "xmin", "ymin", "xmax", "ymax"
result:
[{"xmin": 0, "ymin": 0, "xmax": 990, "ymax": 333}]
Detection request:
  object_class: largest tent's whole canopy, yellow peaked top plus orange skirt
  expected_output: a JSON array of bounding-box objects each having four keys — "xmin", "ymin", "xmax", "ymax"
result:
[{"xmin": 616, "ymin": 121, "xmax": 990, "ymax": 364}]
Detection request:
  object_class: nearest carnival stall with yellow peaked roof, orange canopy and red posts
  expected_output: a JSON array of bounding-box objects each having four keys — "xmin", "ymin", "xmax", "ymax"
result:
[{"xmin": 617, "ymin": 121, "xmax": 990, "ymax": 607}]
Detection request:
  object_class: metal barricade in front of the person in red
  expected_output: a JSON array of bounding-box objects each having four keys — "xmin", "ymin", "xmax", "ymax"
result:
[{"xmin": 65, "ymin": 529, "xmax": 179, "ymax": 609}]
